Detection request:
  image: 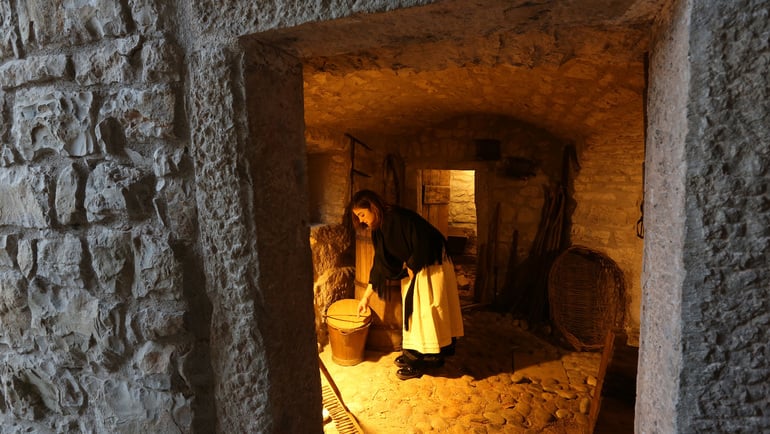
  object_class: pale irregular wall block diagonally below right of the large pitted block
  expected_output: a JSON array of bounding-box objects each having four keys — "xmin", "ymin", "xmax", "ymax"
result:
[{"xmin": 85, "ymin": 161, "xmax": 140, "ymax": 223}]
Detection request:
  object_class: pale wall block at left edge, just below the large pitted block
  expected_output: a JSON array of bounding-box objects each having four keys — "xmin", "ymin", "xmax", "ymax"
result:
[{"xmin": 0, "ymin": 167, "xmax": 50, "ymax": 228}]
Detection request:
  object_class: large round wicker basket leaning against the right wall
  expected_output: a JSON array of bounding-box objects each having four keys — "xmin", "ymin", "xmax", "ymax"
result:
[{"xmin": 548, "ymin": 246, "xmax": 625, "ymax": 351}]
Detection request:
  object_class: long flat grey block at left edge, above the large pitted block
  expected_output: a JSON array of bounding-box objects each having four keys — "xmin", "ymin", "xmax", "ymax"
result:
[{"xmin": 0, "ymin": 54, "xmax": 68, "ymax": 89}]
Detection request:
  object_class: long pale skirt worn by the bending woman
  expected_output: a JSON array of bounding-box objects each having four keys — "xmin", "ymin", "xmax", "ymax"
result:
[{"xmin": 401, "ymin": 258, "xmax": 463, "ymax": 354}]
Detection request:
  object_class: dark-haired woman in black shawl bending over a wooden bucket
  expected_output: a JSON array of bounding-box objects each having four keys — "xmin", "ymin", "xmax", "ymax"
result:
[{"xmin": 348, "ymin": 190, "xmax": 463, "ymax": 380}]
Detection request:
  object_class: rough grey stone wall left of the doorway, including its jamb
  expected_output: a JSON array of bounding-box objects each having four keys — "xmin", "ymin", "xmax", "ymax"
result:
[{"xmin": 0, "ymin": 0, "xmax": 328, "ymax": 432}]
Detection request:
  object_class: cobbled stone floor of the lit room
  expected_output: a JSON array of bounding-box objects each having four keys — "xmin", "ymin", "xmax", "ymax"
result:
[{"xmin": 321, "ymin": 309, "xmax": 601, "ymax": 434}]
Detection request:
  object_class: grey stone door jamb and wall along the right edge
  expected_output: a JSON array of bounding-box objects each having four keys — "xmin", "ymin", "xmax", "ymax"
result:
[{"xmin": 637, "ymin": 0, "xmax": 770, "ymax": 432}]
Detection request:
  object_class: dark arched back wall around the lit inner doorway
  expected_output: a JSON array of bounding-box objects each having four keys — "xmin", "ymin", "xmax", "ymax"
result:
[{"xmin": 383, "ymin": 115, "xmax": 566, "ymax": 302}]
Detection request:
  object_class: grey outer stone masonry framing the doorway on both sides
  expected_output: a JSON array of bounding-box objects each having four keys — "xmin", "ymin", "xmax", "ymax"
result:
[{"xmin": 0, "ymin": 0, "xmax": 770, "ymax": 433}]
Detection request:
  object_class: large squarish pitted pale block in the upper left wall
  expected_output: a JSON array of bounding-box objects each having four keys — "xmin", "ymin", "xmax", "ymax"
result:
[{"xmin": 11, "ymin": 88, "xmax": 94, "ymax": 161}]
